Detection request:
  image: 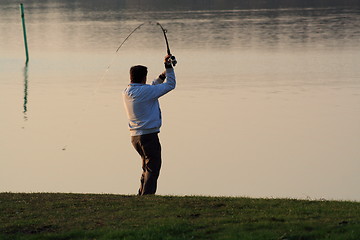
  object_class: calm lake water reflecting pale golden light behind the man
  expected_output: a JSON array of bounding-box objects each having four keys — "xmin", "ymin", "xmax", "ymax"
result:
[{"xmin": 0, "ymin": 0, "xmax": 360, "ymax": 201}]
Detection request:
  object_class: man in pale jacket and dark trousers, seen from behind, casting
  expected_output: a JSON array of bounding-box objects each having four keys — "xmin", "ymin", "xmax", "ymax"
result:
[{"xmin": 123, "ymin": 55, "xmax": 176, "ymax": 195}]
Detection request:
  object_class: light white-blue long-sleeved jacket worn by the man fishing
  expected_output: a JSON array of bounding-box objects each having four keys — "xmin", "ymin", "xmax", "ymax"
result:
[{"xmin": 123, "ymin": 68, "xmax": 176, "ymax": 136}]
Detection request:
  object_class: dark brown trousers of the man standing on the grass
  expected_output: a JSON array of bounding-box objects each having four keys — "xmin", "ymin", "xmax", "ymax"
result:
[{"xmin": 131, "ymin": 133, "xmax": 161, "ymax": 195}]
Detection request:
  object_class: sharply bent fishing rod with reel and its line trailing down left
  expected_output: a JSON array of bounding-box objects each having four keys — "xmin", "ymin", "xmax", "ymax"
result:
[{"xmin": 62, "ymin": 21, "xmax": 177, "ymax": 151}]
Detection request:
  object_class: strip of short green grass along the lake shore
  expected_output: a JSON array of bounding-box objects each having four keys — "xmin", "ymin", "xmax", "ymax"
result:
[{"xmin": 0, "ymin": 193, "xmax": 360, "ymax": 240}]
